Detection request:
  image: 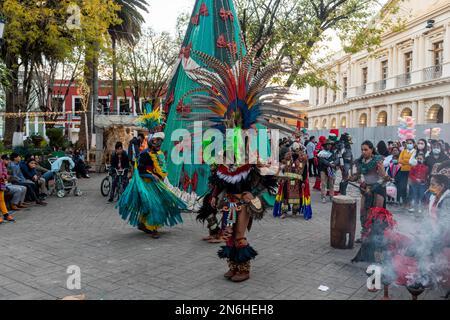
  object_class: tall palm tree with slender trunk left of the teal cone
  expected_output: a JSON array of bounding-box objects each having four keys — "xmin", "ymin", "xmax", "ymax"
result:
[{"xmin": 109, "ymin": 0, "xmax": 148, "ymax": 114}]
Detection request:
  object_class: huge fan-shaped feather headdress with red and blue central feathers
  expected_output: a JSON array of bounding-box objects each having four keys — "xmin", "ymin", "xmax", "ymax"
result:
[{"xmin": 181, "ymin": 42, "xmax": 298, "ymax": 133}]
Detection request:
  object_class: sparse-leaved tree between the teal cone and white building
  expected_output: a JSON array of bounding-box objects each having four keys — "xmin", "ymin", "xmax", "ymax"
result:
[{"xmin": 237, "ymin": 0, "xmax": 402, "ymax": 87}]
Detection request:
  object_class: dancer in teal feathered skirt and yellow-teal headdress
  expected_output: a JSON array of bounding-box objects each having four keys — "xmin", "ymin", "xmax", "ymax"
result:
[{"xmin": 116, "ymin": 105, "xmax": 186, "ymax": 238}]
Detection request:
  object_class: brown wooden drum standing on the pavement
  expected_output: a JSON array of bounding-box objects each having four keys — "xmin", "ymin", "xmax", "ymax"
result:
[{"xmin": 330, "ymin": 196, "xmax": 356, "ymax": 249}]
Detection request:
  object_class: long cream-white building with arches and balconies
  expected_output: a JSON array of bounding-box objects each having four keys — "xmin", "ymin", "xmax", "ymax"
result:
[{"xmin": 308, "ymin": 0, "xmax": 450, "ymax": 129}]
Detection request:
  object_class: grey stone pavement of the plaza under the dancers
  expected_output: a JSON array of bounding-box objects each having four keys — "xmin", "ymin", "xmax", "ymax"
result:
[{"xmin": 0, "ymin": 175, "xmax": 442, "ymax": 300}]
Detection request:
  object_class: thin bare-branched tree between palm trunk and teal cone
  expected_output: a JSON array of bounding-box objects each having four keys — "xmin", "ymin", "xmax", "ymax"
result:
[{"xmin": 117, "ymin": 29, "xmax": 178, "ymax": 112}]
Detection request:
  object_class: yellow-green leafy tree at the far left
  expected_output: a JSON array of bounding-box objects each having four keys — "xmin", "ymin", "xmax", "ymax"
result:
[{"xmin": 0, "ymin": 0, "xmax": 120, "ymax": 143}]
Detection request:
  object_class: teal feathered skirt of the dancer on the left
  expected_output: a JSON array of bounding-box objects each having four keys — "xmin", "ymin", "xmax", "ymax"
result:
[{"xmin": 116, "ymin": 169, "xmax": 187, "ymax": 227}]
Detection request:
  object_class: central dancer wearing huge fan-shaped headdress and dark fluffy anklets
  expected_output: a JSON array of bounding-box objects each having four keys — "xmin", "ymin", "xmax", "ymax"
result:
[{"xmin": 179, "ymin": 42, "xmax": 296, "ymax": 282}]
